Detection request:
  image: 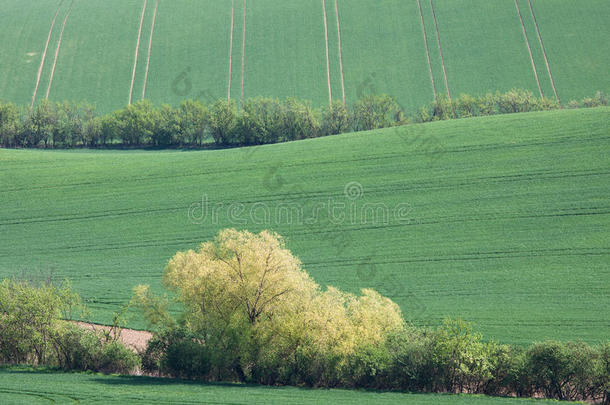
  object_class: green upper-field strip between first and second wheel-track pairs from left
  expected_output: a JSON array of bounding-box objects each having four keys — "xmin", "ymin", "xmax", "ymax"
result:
[{"xmin": 39, "ymin": 0, "xmax": 142, "ymax": 111}]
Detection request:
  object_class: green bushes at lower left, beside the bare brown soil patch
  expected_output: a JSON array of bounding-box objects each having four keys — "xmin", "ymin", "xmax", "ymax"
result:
[{"xmin": 0, "ymin": 279, "xmax": 140, "ymax": 374}]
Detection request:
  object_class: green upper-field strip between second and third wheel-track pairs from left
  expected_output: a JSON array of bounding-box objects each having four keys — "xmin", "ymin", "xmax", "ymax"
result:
[{"xmin": 143, "ymin": 0, "xmax": 230, "ymax": 105}]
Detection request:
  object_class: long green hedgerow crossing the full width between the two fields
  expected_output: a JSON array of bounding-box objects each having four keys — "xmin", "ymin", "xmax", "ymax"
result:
[{"xmin": 0, "ymin": 89, "xmax": 608, "ymax": 148}]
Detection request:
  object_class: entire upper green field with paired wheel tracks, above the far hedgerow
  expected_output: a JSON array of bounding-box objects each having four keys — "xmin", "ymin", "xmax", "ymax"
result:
[{"xmin": 0, "ymin": 0, "xmax": 610, "ymax": 112}]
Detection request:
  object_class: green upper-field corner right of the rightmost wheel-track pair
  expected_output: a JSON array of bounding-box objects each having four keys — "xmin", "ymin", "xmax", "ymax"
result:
[{"xmin": 533, "ymin": 0, "xmax": 610, "ymax": 102}]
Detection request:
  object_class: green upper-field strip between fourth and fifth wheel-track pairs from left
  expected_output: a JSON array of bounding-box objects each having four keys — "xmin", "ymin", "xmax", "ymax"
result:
[{"xmin": 339, "ymin": 0, "xmax": 433, "ymax": 111}]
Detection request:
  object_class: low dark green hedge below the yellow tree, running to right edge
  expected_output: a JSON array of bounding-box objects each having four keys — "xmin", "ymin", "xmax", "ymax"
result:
[{"xmin": 141, "ymin": 319, "xmax": 610, "ymax": 404}]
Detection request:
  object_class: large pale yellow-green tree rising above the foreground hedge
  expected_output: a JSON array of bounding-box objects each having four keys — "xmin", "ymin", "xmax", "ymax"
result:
[{"xmin": 134, "ymin": 229, "xmax": 404, "ymax": 381}]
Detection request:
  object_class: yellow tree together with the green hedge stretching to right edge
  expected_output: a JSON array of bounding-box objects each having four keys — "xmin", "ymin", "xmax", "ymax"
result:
[{"xmin": 132, "ymin": 229, "xmax": 610, "ymax": 403}]
